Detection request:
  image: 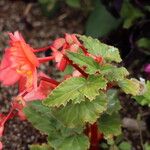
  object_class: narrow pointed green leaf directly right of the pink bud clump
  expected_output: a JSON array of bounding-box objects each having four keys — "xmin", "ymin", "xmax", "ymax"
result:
[{"xmin": 67, "ymin": 52, "xmax": 100, "ymax": 74}]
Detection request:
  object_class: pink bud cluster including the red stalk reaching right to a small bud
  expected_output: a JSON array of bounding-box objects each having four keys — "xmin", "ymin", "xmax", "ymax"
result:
[{"xmin": 50, "ymin": 33, "xmax": 103, "ymax": 71}]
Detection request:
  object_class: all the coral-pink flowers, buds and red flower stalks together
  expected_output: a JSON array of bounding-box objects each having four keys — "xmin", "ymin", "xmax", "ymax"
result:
[{"xmin": 0, "ymin": 31, "xmax": 102, "ymax": 149}]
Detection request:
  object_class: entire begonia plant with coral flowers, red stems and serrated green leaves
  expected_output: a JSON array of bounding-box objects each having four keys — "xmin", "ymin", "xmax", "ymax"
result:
[{"xmin": 0, "ymin": 31, "xmax": 142, "ymax": 150}]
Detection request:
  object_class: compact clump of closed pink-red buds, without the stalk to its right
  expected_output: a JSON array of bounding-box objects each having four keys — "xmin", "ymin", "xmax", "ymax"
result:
[{"xmin": 51, "ymin": 33, "xmax": 81, "ymax": 71}]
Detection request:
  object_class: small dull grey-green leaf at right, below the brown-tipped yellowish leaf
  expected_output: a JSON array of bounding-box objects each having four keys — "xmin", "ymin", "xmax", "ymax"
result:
[{"xmin": 107, "ymin": 89, "xmax": 121, "ymax": 115}]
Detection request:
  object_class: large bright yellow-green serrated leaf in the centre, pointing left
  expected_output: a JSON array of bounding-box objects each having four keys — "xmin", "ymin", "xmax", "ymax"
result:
[{"xmin": 43, "ymin": 75, "xmax": 107, "ymax": 107}]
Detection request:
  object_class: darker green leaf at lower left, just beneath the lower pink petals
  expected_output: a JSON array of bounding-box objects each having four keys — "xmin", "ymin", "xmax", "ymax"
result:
[{"xmin": 24, "ymin": 101, "xmax": 56, "ymax": 134}]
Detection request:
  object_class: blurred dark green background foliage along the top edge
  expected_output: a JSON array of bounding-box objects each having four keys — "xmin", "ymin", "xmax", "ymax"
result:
[{"xmin": 38, "ymin": 0, "xmax": 149, "ymax": 38}]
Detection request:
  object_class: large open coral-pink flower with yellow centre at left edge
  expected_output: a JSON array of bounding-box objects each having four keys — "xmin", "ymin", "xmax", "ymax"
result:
[{"xmin": 0, "ymin": 31, "xmax": 39, "ymax": 90}]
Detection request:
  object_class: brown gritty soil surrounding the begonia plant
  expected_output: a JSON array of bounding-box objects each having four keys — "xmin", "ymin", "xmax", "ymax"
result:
[{"xmin": 0, "ymin": 0, "xmax": 150, "ymax": 150}]
